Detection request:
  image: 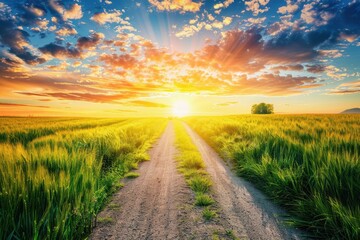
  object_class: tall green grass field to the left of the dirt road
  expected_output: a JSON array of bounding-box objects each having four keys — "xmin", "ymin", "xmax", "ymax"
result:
[{"xmin": 0, "ymin": 118, "xmax": 166, "ymax": 239}]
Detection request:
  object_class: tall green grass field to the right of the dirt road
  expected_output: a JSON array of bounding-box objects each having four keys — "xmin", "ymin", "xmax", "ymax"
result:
[{"xmin": 187, "ymin": 115, "xmax": 360, "ymax": 239}]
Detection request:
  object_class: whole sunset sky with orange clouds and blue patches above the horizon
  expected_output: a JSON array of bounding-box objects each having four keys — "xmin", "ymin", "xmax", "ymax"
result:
[{"xmin": 0, "ymin": 0, "xmax": 360, "ymax": 117}]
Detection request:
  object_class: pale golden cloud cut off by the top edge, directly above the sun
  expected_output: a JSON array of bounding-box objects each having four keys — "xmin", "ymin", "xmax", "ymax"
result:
[{"xmin": 149, "ymin": 0, "xmax": 202, "ymax": 13}]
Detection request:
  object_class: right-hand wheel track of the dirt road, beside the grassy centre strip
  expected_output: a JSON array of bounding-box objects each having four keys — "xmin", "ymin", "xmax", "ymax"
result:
[{"xmin": 185, "ymin": 124, "xmax": 303, "ymax": 240}]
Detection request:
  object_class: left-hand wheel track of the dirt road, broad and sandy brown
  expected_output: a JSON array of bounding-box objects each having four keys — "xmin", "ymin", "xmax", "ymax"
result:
[{"xmin": 90, "ymin": 123, "xmax": 195, "ymax": 240}]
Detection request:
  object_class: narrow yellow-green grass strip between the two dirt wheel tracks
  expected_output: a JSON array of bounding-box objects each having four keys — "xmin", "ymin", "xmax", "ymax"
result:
[{"xmin": 174, "ymin": 121, "xmax": 217, "ymax": 221}]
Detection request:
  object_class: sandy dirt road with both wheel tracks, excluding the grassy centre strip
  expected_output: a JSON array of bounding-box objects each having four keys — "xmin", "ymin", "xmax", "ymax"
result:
[{"xmin": 90, "ymin": 122, "xmax": 306, "ymax": 240}]
